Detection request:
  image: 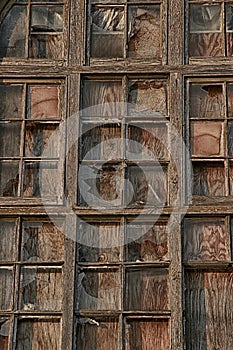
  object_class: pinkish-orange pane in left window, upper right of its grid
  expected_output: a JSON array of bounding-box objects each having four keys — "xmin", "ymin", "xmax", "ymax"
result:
[{"xmin": 27, "ymin": 85, "xmax": 61, "ymax": 119}]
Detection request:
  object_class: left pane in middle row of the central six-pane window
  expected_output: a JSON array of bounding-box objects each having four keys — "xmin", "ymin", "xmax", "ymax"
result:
[{"xmin": 80, "ymin": 124, "xmax": 122, "ymax": 160}]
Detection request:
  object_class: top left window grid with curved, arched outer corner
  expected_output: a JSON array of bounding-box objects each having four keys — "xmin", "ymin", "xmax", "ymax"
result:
[{"xmin": 0, "ymin": 0, "xmax": 64, "ymax": 60}]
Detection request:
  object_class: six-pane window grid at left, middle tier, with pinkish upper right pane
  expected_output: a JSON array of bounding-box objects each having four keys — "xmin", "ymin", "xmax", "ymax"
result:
[{"xmin": 0, "ymin": 80, "xmax": 62, "ymax": 203}]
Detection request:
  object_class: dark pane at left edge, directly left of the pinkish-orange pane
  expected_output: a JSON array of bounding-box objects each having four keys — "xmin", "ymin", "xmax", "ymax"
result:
[{"xmin": 0, "ymin": 84, "xmax": 23, "ymax": 119}]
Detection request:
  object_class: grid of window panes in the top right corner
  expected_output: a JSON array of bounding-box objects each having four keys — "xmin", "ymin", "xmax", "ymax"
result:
[{"xmin": 188, "ymin": 1, "xmax": 233, "ymax": 58}]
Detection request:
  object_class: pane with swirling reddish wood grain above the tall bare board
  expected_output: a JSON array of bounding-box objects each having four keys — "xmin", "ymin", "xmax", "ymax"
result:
[{"xmin": 184, "ymin": 220, "xmax": 229, "ymax": 261}]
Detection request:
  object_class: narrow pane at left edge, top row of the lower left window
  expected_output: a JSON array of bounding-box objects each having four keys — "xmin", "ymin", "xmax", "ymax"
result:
[{"xmin": 0, "ymin": 219, "xmax": 16, "ymax": 261}]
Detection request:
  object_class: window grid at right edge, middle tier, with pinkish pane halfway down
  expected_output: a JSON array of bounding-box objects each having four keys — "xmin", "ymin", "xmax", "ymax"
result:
[{"xmin": 188, "ymin": 79, "xmax": 233, "ymax": 197}]
